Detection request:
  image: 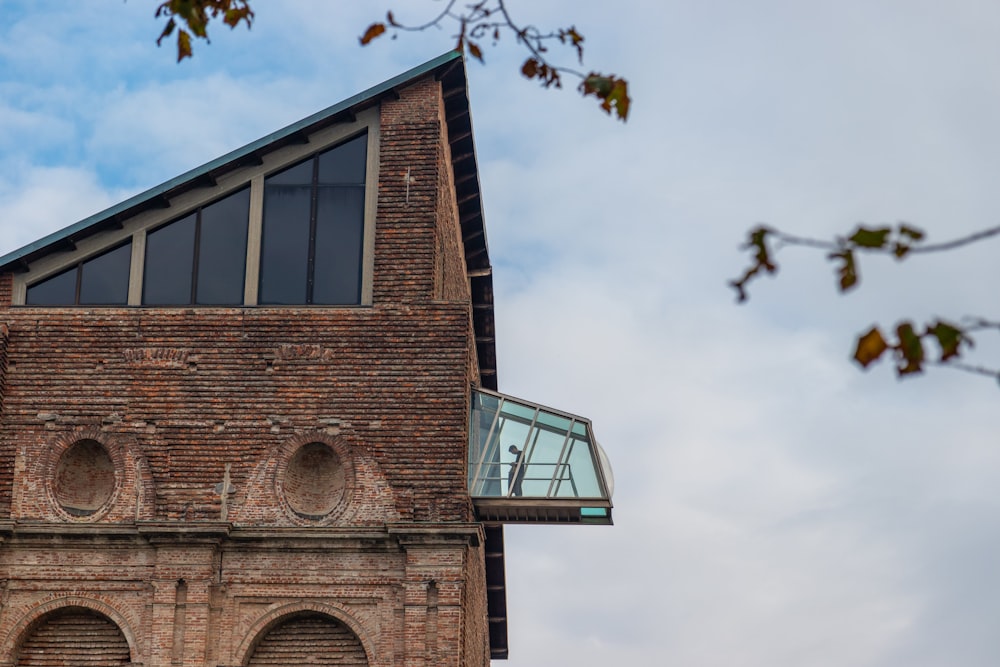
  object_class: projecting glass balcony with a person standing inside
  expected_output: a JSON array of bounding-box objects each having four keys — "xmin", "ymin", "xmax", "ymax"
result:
[{"xmin": 469, "ymin": 389, "xmax": 614, "ymax": 524}]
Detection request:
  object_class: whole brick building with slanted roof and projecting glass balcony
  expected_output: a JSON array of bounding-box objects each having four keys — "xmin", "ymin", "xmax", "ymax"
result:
[{"xmin": 0, "ymin": 54, "xmax": 611, "ymax": 667}]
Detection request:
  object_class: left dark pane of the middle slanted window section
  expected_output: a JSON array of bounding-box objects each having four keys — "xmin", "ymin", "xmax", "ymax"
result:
[{"xmin": 142, "ymin": 213, "xmax": 196, "ymax": 306}]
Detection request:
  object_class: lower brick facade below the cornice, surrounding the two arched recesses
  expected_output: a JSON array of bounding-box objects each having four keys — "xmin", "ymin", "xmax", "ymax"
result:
[{"xmin": 0, "ymin": 524, "xmax": 488, "ymax": 667}]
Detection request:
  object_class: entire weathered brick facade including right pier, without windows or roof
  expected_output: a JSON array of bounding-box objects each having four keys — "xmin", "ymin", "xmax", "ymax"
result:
[{"xmin": 0, "ymin": 77, "xmax": 488, "ymax": 667}]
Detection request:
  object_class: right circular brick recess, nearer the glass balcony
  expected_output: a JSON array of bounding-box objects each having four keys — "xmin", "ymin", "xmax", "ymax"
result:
[{"xmin": 284, "ymin": 442, "xmax": 346, "ymax": 519}]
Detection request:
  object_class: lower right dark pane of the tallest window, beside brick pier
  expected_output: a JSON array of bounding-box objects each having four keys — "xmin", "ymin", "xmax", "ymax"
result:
[{"xmin": 313, "ymin": 187, "xmax": 365, "ymax": 304}]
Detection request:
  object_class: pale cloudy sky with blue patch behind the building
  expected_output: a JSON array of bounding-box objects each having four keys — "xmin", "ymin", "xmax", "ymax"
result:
[{"xmin": 0, "ymin": 0, "xmax": 1000, "ymax": 667}]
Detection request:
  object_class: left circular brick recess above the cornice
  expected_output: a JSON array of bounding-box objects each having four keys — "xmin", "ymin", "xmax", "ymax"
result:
[{"xmin": 53, "ymin": 440, "xmax": 115, "ymax": 516}]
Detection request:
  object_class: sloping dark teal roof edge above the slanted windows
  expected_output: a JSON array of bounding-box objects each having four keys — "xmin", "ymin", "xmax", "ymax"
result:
[{"xmin": 0, "ymin": 51, "xmax": 462, "ymax": 270}]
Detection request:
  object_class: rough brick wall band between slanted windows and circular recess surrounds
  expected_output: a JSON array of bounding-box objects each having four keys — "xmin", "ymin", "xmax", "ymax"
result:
[{"xmin": 0, "ymin": 303, "xmax": 469, "ymax": 521}]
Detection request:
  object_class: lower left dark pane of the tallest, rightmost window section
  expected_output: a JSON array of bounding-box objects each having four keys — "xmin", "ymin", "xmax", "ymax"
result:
[{"xmin": 259, "ymin": 180, "xmax": 311, "ymax": 304}]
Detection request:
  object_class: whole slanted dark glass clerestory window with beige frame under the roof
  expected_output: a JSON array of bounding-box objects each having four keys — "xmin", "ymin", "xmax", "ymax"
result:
[{"xmin": 13, "ymin": 119, "xmax": 378, "ymax": 306}]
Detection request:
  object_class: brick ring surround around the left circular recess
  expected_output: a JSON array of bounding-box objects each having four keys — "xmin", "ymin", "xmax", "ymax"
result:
[{"xmin": 38, "ymin": 426, "xmax": 155, "ymax": 523}]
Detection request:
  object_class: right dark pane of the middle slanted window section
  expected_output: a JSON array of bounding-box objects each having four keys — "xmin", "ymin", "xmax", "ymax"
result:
[{"xmin": 196, "ymin": 189, "xmax": 250, "ymax": 305}]
